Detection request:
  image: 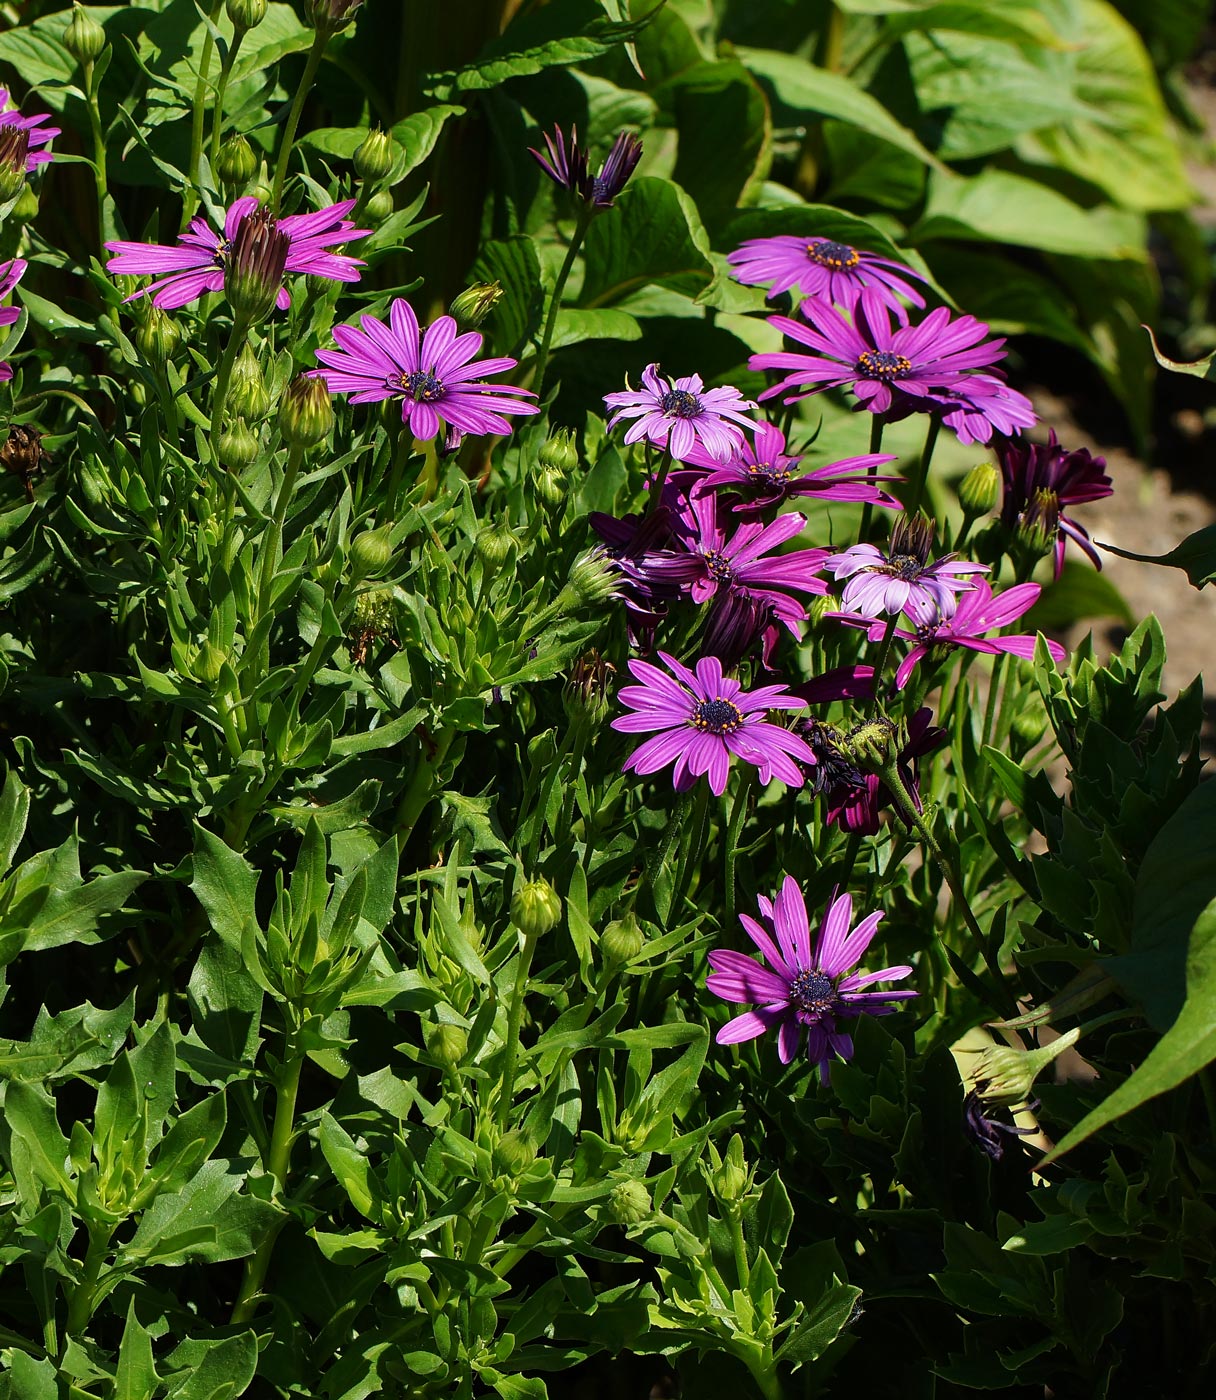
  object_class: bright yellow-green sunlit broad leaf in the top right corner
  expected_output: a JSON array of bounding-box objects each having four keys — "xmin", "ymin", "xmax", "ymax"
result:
[{"xmin": 1017, "ymin": 0, "xmax": 1195, "ymax": 211}]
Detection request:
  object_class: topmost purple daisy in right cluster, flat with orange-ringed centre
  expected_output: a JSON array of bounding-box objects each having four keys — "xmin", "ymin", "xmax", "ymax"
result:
[{"xmin": 726, "ymin": 234, "xmax": 925, "ymax": 323}]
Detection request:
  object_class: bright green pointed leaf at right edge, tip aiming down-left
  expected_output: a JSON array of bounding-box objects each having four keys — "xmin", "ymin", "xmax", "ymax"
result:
[{"xmin": 1044, "ymin": 896, "xmax": 1216, "ymax": 1162}]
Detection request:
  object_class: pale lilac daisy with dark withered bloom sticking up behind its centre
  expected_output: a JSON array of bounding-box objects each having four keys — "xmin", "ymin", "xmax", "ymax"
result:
[{"xmin": 824, "ymin": 517, "xmax": 988, "ymax": 626}]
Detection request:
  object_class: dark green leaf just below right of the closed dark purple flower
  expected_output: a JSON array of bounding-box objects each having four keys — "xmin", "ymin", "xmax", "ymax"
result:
[{"xmin": 579, "ymin": 176, "xmax": 714, "ymax": 308}]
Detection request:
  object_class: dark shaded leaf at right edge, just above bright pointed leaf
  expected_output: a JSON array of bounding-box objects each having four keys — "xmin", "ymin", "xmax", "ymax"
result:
[{"xmin": 1100, "ymin": 783, "xmax": 1216, "ymax": 1030}]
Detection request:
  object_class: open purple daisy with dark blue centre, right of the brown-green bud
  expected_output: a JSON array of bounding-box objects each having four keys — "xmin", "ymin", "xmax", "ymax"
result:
[{"xmin": 313, "ymin": 298, "xmax": 540, "ymax": 440}]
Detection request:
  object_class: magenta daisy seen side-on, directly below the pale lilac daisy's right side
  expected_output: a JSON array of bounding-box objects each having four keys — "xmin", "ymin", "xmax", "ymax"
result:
[{"xmin": 686, "ymin": 423, "xmax": 901, "ymax": 515}]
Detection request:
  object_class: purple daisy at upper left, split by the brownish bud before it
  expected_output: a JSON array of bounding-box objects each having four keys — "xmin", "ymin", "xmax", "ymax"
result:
[{"xmin": 105, "ymin": 195, "xmax": 371, "ymax": 311}]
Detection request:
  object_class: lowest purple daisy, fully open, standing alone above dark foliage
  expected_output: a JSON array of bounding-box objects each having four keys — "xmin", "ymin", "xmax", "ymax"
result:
[{"xmin": 705, "ymin": 875, "xmax": 917, "ymax": 1084}]
